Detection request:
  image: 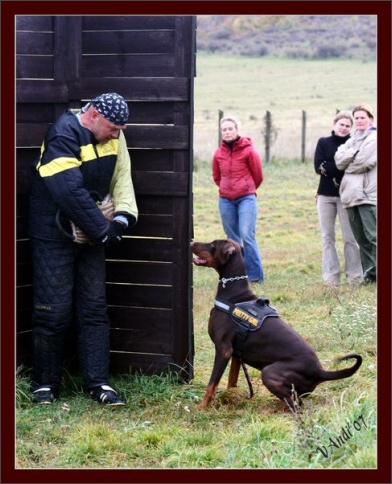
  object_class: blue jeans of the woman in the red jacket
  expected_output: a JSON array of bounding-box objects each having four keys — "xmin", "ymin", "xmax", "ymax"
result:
[{"xmin": 219, "ymin": 195, "xmax": 264, "ymax": 282}]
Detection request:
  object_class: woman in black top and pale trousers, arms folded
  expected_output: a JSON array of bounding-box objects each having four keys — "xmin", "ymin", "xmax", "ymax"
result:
[{"xmin": 314, "ymin": 111, "xmax": 362, "ymax": 285}]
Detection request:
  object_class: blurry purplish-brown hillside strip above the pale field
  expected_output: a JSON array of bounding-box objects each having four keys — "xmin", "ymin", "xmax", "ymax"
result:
[{"xmin": 197, "ymin": 15, "xmax": 377, "ymax": 60}]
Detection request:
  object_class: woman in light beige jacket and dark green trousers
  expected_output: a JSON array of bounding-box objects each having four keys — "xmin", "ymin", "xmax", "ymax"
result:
[{"xmin": 335, "ymin": 104, "xmax": 377, "ymax": 284}]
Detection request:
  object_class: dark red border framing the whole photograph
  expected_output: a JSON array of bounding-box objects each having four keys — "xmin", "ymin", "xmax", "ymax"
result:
[{"xmin": 0, "ymin": 0, "xmax": 392, "ymax": 483}]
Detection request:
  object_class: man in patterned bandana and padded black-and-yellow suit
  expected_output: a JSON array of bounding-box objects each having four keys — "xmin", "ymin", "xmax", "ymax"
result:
[{"xmin": 29, "ymin": 93, "xmax": 138, "ymax": 405}]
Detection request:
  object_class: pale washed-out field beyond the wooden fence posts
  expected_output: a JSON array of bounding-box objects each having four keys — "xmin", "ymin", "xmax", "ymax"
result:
[{"xmin": 194, "ymin": 52, "xmax": 377, "ymax": 159}]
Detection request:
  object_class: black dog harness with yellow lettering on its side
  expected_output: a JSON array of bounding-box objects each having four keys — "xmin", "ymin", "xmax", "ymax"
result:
[{"xmin": 215, "ymin": 298, "xmax": 279, "ymax": 358}]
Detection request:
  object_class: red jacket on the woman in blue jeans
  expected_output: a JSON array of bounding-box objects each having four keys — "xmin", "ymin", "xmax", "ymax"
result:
[{"xmin": 212, "ymin": 136, "xmax": 263, "ymax": 200}]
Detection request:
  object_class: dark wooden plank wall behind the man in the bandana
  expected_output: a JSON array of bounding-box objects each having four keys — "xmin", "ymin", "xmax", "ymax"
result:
[{"xmin": 16, "ymin": 15, "xmax": 196, "ymax": 380}]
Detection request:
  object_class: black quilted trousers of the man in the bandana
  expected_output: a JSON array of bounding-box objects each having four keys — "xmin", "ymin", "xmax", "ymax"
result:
[{"xmin": 31, "ymin": 239, "xmax": 110, "ymax": 391}]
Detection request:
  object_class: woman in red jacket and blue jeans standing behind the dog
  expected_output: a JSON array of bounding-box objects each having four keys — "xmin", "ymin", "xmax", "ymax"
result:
[{"xmin": 212, "ymin": 117, "xmax": 264, "ymax": 283}]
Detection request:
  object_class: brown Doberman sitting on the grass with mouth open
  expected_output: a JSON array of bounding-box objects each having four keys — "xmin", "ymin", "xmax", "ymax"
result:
[{"xmin": 190, "ymin": 239, "xmax": 362, "ymax": 410}]
